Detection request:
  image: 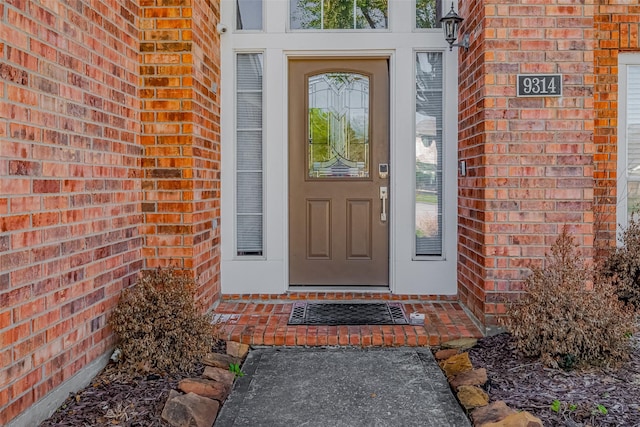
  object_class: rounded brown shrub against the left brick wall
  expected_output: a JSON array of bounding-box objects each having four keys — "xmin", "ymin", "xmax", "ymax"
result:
[{"xmin": 110, "ymin": 269, "xmax": 215, "ymax": 373}]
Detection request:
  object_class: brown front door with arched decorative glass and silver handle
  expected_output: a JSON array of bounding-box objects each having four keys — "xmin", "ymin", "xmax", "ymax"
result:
[{"xmin": 289, "ymin": 58, "xmax": 389, "ymax": 286}]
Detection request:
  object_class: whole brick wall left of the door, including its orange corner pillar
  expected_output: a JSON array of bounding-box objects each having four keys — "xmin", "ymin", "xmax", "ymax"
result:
[{"xmin": 0, "ymin": 0, "xmax": 220, "ymax": 425}]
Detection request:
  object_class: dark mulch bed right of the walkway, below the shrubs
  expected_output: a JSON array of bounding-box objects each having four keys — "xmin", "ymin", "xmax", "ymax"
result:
[{"xmin": 469, "ymin": 333, "xmax": 640, "ymax": 427}]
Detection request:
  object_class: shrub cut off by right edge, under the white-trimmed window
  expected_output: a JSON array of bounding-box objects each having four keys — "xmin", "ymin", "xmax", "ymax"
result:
[{"xmin": 601, "ymin": 214, "xmax": 640, "ymax": 311}]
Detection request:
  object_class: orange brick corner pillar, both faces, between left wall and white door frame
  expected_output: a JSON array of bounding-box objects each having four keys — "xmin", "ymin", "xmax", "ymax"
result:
[{"xmin": 140, "ymin": 0, "xmax": 220, "ymax": 306}]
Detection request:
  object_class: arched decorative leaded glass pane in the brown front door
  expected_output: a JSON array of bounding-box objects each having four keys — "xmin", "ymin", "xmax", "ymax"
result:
[{"xmin": 307, "ymin": 73, "xmax": 369, "ymax": 178}]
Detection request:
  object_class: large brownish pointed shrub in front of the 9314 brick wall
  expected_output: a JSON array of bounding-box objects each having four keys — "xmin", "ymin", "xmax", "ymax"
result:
[{"xmin": 505, "ymin": 229, "xmax": 633, "ymax": 369}]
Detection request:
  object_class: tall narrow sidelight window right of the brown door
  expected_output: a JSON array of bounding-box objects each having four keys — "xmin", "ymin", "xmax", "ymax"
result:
[{"xmin": 415, "ymin": 52, "xmax": 443, "ymax": 256}]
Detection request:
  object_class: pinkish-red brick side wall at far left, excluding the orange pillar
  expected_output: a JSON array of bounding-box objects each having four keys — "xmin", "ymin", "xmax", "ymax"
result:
[{"xmin": 0, "ymin": 0, "xmax": 142, "ymax": 425}]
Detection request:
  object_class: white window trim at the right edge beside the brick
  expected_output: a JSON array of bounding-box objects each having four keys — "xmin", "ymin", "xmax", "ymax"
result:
[{"xmin": 616, "ymin": 53, "xmax": 640, "ymax": 231}]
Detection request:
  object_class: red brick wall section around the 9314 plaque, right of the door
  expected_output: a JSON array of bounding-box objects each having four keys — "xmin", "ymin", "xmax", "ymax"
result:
[{"xmin": 459, "ymin": 0, "xmax": 594, "ymax": 324}]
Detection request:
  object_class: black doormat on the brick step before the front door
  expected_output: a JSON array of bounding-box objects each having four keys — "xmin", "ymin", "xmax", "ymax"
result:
[{"xmin": 289, "ymin": 302, "xmax": 409, "ymax": 326}]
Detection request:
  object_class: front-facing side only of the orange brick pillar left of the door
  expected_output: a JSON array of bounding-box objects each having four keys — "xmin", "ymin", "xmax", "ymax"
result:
[{"xmin": 140, "ymin": 0, "xmax": 193, "ymax": 270}]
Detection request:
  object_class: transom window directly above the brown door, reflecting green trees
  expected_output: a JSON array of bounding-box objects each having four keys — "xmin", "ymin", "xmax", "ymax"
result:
[{"xmin": 289, "ymin": 0, "xmax": 388, "ymax": 30}]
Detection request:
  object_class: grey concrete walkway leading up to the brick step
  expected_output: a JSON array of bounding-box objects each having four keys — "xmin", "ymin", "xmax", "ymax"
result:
[{"xmin": 215, "ymin": 347, "xmax": 470, "ymax": 427}]
